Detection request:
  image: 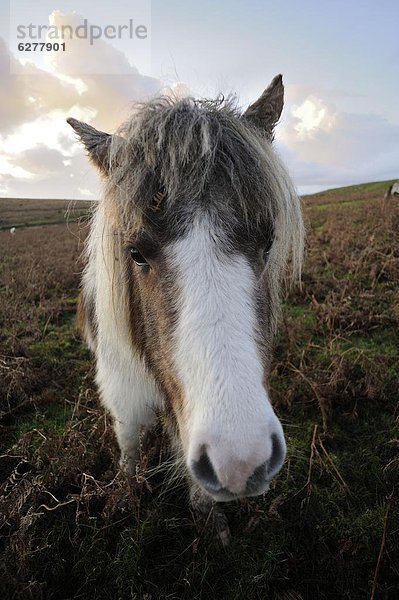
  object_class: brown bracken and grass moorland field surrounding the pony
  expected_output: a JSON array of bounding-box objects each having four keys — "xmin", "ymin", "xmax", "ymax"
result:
[{"xmin": 0, "ymin": 182, "xmax": 399, "ymax": 600}]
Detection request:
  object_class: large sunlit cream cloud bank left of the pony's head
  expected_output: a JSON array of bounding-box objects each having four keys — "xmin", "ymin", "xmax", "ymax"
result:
[{"xmin": 0, "ymin": 11, "xmax": 162, "ymax": 197}]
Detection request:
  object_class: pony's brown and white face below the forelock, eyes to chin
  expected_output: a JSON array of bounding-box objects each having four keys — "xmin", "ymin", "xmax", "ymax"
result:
[{"xmin": 124, "ymin": 197, "xmax": 285, "ymax": 500}]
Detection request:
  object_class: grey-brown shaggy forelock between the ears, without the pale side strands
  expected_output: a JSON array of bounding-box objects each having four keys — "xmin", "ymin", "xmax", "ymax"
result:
[{"xmin": 110, "ymin": 97, "xmax": 270, "ymax": 221}]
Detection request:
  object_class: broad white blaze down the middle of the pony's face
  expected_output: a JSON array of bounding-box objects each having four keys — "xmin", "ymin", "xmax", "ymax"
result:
[{"xmin": 166, "ymin": 218, "xmax": 285, "ymax": 493}]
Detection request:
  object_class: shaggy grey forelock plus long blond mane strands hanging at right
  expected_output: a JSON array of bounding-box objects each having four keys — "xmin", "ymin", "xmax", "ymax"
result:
[{"xmin": 102, "ymin": 97, "xmax": 303, "ymax": 336}]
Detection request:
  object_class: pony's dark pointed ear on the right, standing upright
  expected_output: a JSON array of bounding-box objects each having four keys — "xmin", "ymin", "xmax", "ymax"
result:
[{"xmin": 244, "ymin": 75, "xmax": 284, "ymax": 139}]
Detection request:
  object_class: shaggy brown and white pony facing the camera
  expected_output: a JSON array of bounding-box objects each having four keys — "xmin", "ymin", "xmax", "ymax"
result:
[{"xmin": 67, "ymin": 75, "xmax": 304, "ymax": 503}]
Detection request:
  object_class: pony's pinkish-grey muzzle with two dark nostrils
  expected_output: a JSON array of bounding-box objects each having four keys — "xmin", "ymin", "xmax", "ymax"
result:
[{"xmin": 189, "ymin": 433, "xmax": 286, "ymax": 502}]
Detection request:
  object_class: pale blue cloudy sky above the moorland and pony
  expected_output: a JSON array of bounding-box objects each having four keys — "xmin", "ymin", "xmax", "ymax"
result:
[{"xmin": 0, "ymin": 0, "xmax": 399, "ymax": 199}]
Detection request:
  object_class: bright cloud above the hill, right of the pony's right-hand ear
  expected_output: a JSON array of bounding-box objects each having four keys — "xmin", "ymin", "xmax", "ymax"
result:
[{"xmin": 278, "ymin": 91, "xmax": 399, "ymax": 186}]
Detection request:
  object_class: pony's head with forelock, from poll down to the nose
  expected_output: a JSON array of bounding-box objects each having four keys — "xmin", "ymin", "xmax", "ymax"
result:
[{"xmin": 69, "ymin": 79, "xmax": 301, "ymax": 501}]
